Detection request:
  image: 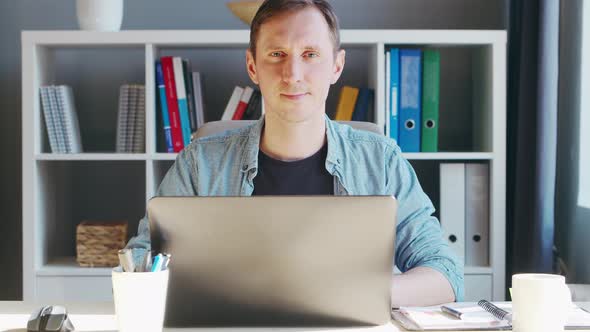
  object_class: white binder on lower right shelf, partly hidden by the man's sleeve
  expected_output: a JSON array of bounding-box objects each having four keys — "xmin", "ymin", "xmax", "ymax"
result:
[{"xmin": 440, "ymin": 163, "xmax": 465, "ymax": 261}]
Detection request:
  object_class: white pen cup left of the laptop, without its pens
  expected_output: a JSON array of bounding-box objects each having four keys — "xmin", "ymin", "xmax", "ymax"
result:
[{"xmin": 112, "ymin": 267, "xmax": 168, "ymax": 332}]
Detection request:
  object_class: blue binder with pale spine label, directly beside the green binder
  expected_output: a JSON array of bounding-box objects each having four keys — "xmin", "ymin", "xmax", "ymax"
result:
[{"xmin": 400, "ymin": 49, "xmax": 422, "ymax": 152}]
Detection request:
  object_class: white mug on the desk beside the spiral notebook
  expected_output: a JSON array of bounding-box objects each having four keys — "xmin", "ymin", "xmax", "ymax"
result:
[{"xmin": 512, "ymin": 273, "xmax": 572, "ymax": 332}]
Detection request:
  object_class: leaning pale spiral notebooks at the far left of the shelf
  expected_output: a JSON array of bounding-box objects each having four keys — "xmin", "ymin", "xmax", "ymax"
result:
[{"xmin": 40, "ymin": 85, "xmax": 82, "ymax": 153}]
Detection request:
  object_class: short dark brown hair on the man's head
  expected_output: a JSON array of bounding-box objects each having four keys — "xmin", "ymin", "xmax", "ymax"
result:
[{"xmin": 250, "ymin": 0, "xmax": 340, "ymax": 60}]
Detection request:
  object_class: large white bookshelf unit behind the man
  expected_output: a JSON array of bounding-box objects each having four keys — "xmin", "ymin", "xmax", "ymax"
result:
[{"xmin": 21, "ymin": 30, "xmax": 506, "ymax": 302}]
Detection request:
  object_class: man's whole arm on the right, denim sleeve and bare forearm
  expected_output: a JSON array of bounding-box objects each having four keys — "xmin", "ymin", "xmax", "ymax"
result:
[{"xmin": 388, "ymin": 148, "xmax": 464, "ymax": 306}]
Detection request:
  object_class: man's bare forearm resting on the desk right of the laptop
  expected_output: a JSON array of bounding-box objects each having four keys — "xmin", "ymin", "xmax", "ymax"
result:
[{"xmin": 391, "ymin": 267, "xmax": 455, "ymax": 308}]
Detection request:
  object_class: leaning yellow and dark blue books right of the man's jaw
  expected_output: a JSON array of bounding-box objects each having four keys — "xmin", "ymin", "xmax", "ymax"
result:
[{"xmin": 334, "ymin": 86, "xmax": 375, "ymax": 121}]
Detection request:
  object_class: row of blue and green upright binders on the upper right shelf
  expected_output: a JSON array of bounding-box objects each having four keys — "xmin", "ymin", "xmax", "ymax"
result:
[{"xmin": 385, "ymin": 48, "xmax": 440, "ymax": 152}]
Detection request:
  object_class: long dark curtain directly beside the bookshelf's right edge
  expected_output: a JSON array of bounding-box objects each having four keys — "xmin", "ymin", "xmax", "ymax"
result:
[{"xmin": 506, "ymin": 0, "xmax": 559, "ymax": 286}]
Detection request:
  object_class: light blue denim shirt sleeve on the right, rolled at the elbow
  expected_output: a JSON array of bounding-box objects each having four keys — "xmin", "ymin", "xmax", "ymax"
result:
[{"xmin": 388, "ymin": 147, "xmax": 464, "ymax": 302}]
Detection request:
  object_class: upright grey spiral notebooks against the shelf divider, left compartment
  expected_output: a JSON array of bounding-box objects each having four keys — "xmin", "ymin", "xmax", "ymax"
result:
[{"xmin": 116, "ymin": 84, "xmax": 145, "ymax": 153}]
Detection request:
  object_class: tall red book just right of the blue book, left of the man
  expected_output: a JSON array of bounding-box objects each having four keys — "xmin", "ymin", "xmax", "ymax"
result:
[{"xmin": 160, "ymin": 56, "xmax": 184, "ymax": 152}]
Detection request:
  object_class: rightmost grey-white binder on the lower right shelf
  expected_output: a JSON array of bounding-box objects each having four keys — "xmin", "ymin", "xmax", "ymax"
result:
[{"xmin": 465, "ymin": 164, "xmax": 490, "ymax": 266}]
